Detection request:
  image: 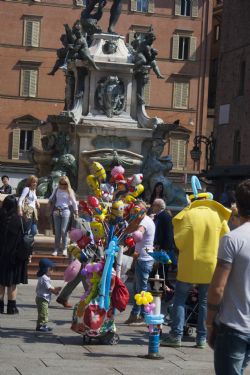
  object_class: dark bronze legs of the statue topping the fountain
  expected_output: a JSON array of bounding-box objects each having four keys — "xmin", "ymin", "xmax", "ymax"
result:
[{"xmin": 81, "ymin": 0, "xmax": 122, "ymax": 34}]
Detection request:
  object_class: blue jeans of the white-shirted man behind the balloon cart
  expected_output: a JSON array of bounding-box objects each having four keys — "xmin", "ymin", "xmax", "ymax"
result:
[{"xmin": 131, "ymin": 259, "xmax": 154, "ymax": 315}]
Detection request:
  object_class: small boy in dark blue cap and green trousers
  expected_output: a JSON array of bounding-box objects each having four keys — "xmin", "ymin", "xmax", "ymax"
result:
[{"xmin": 36, "ymin": 258, "xmax": 61, "ymax": 332}]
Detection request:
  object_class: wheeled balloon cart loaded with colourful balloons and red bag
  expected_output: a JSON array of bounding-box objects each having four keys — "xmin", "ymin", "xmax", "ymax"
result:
[{"xmin": 69, "ymin": 162, "xmax": 144, "ymax": 345}]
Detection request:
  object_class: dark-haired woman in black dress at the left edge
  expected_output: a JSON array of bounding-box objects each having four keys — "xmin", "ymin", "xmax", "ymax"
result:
[{"xmin": 0, "ymin": 195, "xmax": 28, "ymax": 314}]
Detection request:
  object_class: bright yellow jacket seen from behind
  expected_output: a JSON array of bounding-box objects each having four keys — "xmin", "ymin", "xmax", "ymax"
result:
[{"xmin": 173, "ymin": 200, "xmax": 231, "ymax": 284}]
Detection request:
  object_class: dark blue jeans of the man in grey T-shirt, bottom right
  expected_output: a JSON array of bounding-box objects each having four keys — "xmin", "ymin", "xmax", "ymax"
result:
[{"xmin": 214, "ymin": 324, "xmax": 250, "ymax": 375}]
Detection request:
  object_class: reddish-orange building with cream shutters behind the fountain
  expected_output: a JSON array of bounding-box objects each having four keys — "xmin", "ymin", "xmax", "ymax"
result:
[{"xmin": 0, "ymin": 0, "xmax": 212, "ymax": 192}]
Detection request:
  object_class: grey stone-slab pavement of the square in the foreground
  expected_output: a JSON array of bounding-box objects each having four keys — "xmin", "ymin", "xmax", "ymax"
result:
[{"xmin": 0, "ymin": 280, "xmax": 250, "ymax": 375}]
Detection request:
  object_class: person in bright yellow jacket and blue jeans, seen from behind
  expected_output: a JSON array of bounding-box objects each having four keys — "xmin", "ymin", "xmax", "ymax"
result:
[{"xmin": 161, "ymin": 193, "xmax": 231, "ymax": 349}]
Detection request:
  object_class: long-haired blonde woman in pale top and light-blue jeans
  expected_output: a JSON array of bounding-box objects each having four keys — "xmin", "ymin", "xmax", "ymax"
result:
[{"xmin": 49, "ymin": 176, "xmax": 78, "ymax": 256}]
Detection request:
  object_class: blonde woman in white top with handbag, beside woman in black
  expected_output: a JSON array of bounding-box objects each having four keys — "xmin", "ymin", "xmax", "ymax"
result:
[{"xmin": 18, "ymin": 175, "xmax": 40, "ymax": 236}]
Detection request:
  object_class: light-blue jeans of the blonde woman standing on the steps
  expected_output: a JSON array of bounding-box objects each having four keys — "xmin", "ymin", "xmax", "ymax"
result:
[{"xmin": 53, "ymin": 209, "xmax": 70, "ymax": 251}]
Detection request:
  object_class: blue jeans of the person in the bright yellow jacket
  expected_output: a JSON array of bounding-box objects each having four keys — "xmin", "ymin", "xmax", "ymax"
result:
[{"xmin": 170, "ymin": 281, "xmax": 208, "ymax": 342}]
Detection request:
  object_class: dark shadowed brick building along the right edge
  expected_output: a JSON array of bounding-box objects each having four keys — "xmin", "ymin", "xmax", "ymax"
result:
[{"xmin": 209, "ymin": 0, "xmax": 250, "ymax": 195}]
